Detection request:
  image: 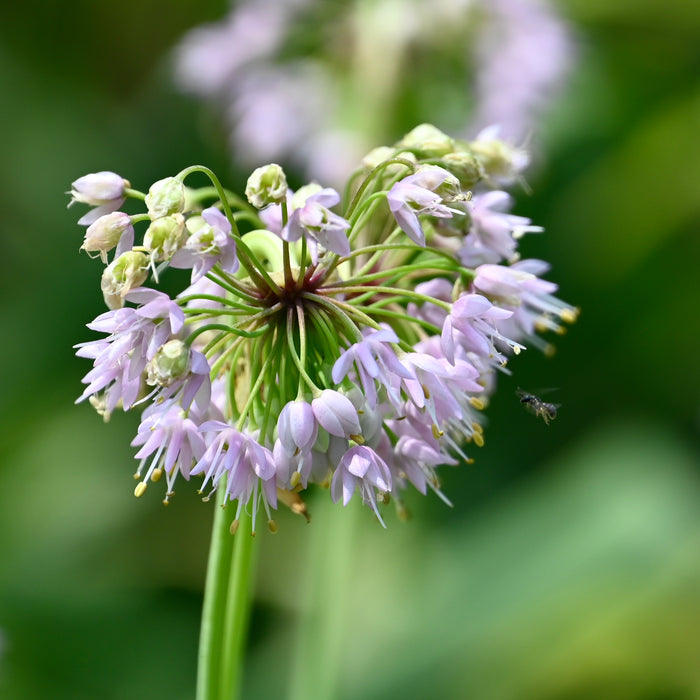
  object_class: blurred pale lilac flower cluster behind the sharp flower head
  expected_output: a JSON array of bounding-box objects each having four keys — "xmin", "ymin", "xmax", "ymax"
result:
[{"xmin": 175, "ymin": 0, "xmax": 575, "ymax": 184}]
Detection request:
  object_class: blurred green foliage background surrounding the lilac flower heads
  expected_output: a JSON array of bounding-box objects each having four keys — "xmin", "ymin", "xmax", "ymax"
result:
[{"xmin": 0, "ymin": 0, "xmax": 700, "ymax": 700}]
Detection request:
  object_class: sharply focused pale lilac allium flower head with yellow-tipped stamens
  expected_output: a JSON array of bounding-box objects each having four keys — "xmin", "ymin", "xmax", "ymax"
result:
[{"xmin": 71, "ymin": 125, "xmax": 577, "ymax": 531}]
